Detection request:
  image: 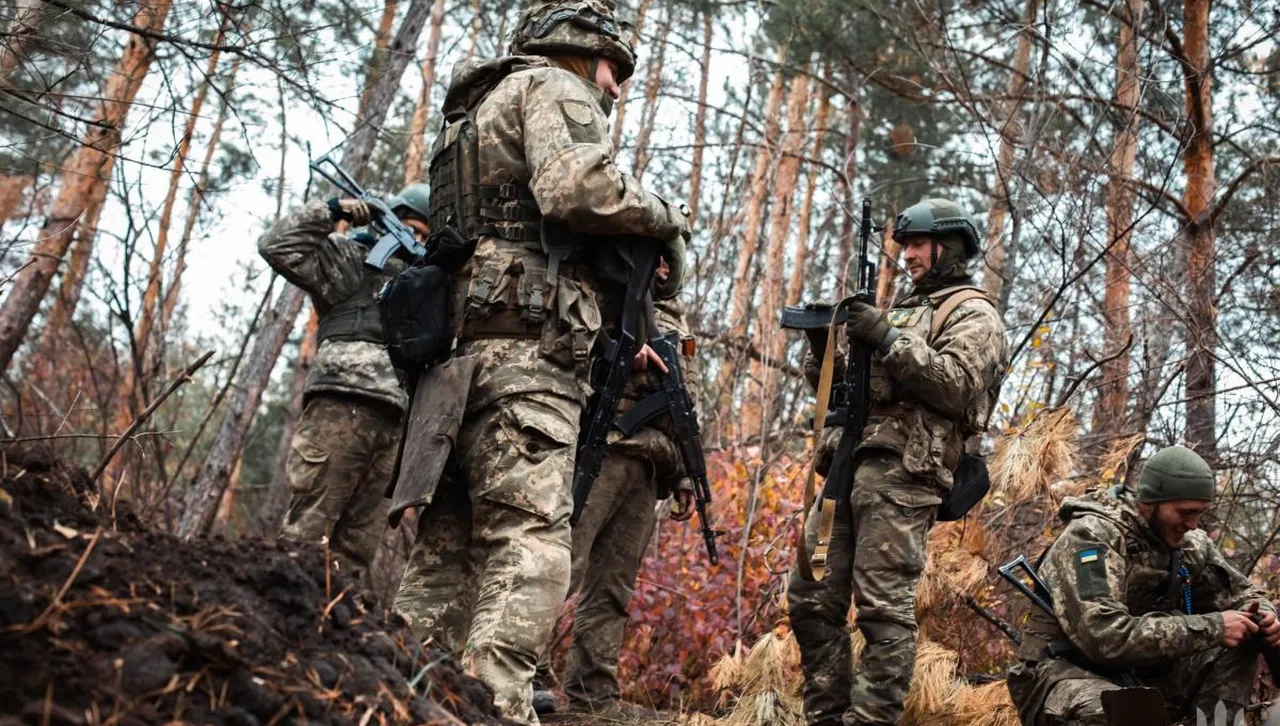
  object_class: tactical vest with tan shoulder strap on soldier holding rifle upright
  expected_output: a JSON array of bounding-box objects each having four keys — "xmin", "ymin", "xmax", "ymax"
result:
[{"xmin": 860, "ymin": 286, "xmax": 1000, "ymax": 479}]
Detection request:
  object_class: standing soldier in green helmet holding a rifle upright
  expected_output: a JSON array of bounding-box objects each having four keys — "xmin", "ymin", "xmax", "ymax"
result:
[{"xmin": 788, "ymin": 198, "xmax": 1006, "ymax": 726}]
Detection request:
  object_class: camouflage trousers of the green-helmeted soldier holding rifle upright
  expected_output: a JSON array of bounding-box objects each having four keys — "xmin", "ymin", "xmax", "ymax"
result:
[{"xmin": 787, "ymin": 451, "xmax": 942, "ymax": 726}]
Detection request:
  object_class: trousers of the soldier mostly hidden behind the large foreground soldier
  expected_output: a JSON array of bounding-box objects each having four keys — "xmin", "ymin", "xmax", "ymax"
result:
[{"xmin": 564, "ymin": 451, "xmax": 658, "ymax": 709}]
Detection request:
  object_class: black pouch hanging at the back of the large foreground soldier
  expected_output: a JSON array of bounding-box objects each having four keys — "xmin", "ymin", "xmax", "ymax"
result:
[{"xmin": 378, "ymin": 265, "xmax": 454, "ymax": 373}]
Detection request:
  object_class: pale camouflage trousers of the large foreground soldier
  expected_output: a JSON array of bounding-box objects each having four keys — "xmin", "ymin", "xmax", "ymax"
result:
[{"xmin": 394, "ymin": 342, "xmax": 582, "ymax": 723}]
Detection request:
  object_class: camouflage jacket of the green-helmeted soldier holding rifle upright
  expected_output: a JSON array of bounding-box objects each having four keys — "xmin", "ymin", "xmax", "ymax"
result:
[{"xmin": 805, "ymin": 284, "xmax": 1009, "ymax": 488}]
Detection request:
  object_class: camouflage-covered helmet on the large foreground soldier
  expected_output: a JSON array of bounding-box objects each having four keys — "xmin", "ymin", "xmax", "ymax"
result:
[{"xmin": 511, "ymin": 0, "xmax": 636, "ymax": 85}]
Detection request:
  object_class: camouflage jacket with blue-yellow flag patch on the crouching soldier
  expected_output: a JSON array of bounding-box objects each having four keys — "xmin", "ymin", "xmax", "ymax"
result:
[{"xmin": 1021, "ymin": 490, "xmax": 1274, "ymax": 668}]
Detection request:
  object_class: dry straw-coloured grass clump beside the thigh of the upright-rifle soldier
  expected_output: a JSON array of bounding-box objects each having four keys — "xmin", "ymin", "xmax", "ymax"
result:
[{"xmin": 915, "ymin": 519, "xmax": 989, "ymax": 621}]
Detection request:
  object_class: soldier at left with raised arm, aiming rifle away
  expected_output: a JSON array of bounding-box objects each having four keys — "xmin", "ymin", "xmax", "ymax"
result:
[{"xmin": 257, "ymin": 184, "xmax": 428, "ymax": 576}]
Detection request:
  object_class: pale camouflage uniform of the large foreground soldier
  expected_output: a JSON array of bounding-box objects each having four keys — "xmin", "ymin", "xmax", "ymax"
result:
[{"xmin": 394, "ymin": 49, "xmax": 684, "ymax": 723}]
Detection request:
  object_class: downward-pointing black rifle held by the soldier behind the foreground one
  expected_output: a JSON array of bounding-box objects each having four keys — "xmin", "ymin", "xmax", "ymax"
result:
[{"xmin": 614, "ymin": 297, "xmax": 724, "ymax": 565}]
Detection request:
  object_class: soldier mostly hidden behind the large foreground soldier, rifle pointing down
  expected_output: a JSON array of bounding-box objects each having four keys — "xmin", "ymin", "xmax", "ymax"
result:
[{"xmin": 535, "ymin": 288, "xmax": 698, "ymax": 717}]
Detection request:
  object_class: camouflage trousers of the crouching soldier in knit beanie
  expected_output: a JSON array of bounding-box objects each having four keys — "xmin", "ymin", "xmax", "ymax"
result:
[{"xmin": 1010, "ymin": 648, "xmax": 1258, "ymax": 726}]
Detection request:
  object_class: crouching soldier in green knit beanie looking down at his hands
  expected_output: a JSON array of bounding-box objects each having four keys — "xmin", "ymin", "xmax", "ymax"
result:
[{"xmin": 1009, "ymin": 446, "xmax": 1280, "ymax": 726}]
